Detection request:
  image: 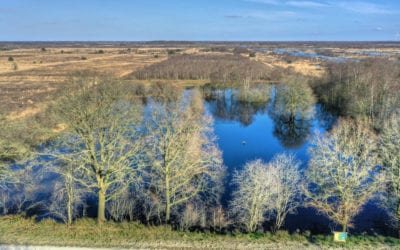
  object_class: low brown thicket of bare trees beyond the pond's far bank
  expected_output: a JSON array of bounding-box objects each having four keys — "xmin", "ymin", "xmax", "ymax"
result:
[{"xmin": 134, "ymin": 54, "xmax": 281, "ymax": 84}]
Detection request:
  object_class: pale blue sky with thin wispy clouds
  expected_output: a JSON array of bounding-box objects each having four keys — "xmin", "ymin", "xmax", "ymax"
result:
[{"xmin": 0, "ymin": 0, "xmax": 400, "ymax": 41}]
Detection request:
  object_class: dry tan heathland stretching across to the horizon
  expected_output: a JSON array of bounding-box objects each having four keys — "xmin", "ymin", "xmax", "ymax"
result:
[{"xmin": 0, "ymin": 43, "xmax": 400, "ymax": 119}]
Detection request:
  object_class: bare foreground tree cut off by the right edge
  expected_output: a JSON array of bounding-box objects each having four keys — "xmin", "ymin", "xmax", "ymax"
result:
[{"xmin": 379, "ymin": 116, "xmax": 400, "ymax": 235}]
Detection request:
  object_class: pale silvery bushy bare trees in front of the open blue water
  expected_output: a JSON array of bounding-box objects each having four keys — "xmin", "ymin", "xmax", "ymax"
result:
[{"xmin": 231, "ymin": 154, "xmax": 300, "ymax": 233}]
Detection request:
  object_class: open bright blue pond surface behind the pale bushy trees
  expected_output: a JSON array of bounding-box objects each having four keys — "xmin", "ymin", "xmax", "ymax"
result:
[{"xmin": 205, "ymin": 86, "xmax": 334, "ymax": 172}]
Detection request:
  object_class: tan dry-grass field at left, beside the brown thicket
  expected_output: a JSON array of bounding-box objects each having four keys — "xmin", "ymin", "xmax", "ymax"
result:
[{"xmin": 0, "ymin": 48, "xmax": 167, "ymax": 118}]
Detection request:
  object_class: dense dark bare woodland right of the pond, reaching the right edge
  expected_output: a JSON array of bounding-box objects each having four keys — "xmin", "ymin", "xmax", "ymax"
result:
[{"xmin": 313, "ymin": 59, "xmax": 400, "ymax": 129}]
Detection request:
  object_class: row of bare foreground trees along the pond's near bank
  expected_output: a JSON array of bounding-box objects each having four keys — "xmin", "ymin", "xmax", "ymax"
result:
[{"xmin": 0, "ymin": 76, "xmax": 400, "ymax": 237}]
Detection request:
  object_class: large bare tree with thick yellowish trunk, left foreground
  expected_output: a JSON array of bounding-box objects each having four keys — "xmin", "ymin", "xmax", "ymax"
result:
[{"xmin": 50, "ymin": 76, "xmax": 142, "ymax": 223}]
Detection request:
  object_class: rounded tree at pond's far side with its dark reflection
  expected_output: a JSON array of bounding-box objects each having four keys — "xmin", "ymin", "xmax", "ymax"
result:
[{"xmin": 269, "ymin": 78, "xmax": 316, "ymax": 149}]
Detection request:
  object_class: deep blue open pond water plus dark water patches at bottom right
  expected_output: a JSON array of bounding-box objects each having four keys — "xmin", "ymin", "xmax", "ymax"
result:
[{"xmin": 204, "ymin": 85, "xmax": 390, "ymax": 234}]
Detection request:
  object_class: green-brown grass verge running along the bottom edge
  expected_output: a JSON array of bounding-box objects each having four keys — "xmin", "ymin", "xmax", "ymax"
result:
[{"xmin": 0, "ymin": 216, "xmax": 400, "ymax": 249}]
